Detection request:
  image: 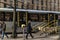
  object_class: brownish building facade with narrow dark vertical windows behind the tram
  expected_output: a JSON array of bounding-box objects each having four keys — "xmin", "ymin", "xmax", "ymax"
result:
[{"xmin": 0, "ymin": 0, "xmax": 60, "ymax": 11}]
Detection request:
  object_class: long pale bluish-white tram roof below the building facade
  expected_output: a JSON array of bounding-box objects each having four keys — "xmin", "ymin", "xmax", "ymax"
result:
[{"xmin": 0, "ymin": 8, "xmax": 60, "ymax": 14}]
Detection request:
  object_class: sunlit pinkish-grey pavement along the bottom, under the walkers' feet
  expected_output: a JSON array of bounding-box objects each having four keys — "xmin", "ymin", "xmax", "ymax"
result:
[{"xmin": 0, "ymin": 34, "xmax": 59, "ymax": 40}]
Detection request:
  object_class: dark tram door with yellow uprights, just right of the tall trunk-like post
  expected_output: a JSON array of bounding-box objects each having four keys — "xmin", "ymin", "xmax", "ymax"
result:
[{"xmin": 17, "ymin": 12, "xmax": 27, "ymax": 27}]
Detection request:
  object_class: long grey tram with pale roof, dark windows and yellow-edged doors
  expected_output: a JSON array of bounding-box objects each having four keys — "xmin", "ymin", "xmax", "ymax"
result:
[{"xmin": 0, "ymin": 8, "xmax": 60, "ymax": 32}]
